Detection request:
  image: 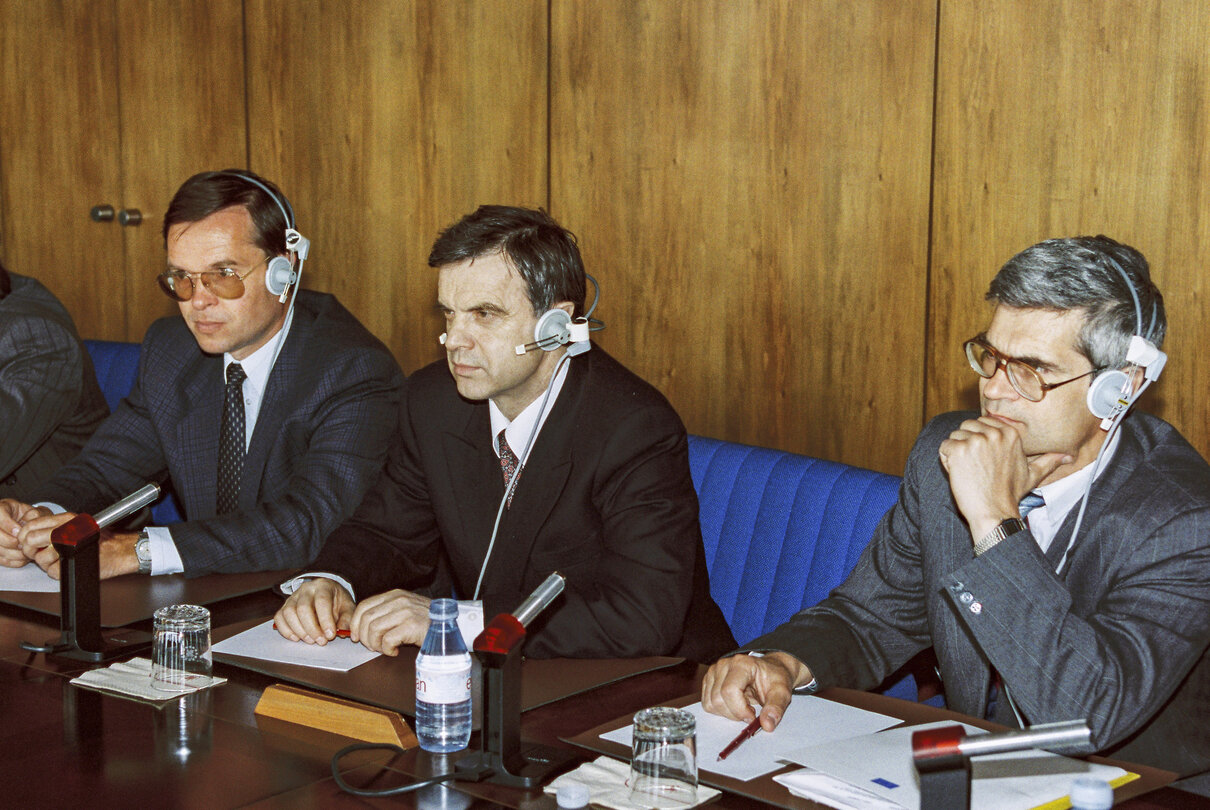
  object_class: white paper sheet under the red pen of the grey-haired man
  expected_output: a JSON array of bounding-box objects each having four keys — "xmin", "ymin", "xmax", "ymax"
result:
[{"xmin": 601, "ymin": 695, "xmax": 900, "ymax": 781}]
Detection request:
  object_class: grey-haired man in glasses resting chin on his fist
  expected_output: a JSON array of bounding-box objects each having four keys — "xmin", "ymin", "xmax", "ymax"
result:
[{"xmin": 702, "ymin": 236, "xmax": 1210, "ymax": 774}]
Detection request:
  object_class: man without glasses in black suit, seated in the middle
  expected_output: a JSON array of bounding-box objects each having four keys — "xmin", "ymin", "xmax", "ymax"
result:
[{"xmin": 276, "ymin": 206, "xmax": 734, "ymax": 661}]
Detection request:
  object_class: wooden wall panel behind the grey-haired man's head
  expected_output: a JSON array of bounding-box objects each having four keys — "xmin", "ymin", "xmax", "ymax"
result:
[{"xmin": 926, "ymin": 0, "xmax": 1210, "ymax": 456}]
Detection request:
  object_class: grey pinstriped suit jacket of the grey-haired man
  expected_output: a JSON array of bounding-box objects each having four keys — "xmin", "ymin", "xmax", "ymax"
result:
[{"xmin": 749, "ymin": 413, "xmax": 1210, "ymax": 774}]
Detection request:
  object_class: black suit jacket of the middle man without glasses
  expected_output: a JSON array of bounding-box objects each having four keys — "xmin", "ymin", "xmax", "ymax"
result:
[{"xmin": 302, "ymin": 347, "xmax": 734, "ymax": 661}]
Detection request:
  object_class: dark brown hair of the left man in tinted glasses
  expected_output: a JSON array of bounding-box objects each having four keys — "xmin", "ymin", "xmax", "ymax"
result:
[{"xmin": 163, "ymin": 168, "xmax": 293, "ymax": 255}]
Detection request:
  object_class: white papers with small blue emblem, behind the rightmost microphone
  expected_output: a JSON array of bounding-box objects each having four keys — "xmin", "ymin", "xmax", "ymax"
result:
[{"xmin": 788, "ymin": 722, "xmax": 1127, "ymax": 810}]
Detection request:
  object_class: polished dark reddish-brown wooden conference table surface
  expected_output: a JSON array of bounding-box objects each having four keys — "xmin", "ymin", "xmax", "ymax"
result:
[{"xmin": 0, "ymin": 573, "xmax": 1210, "ymax": 810}]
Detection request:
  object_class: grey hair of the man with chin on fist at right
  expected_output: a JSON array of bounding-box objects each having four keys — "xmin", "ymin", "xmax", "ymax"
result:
[{"xmin": 987, "ymin": 236, "xmax": 1168, "ymax": 368}]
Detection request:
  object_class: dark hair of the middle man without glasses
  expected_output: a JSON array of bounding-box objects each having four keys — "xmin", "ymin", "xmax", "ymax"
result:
[{"xmin": 428, "ymin": 206, "xmax": 586, "ymax": 317}]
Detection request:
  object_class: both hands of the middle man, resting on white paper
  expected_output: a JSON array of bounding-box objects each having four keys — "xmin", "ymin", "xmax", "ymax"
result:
[{"xmin": 273, "ymin": 578, "xmax": 431, "ymax": 655}]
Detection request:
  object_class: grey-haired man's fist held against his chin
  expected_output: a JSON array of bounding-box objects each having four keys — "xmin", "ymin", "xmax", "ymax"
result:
[{"xmin": 939, "ymin": 417, "xmax": 1073, "ymax": 541}]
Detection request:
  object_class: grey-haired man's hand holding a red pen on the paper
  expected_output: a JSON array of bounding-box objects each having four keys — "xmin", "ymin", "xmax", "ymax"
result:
[{"xmin": 702, "ymin": 653, "xmax": 811, "ymax": 731}]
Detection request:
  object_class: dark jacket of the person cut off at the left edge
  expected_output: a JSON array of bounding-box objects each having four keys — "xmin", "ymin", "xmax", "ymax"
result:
[{"xmin": 0, "ymin": 272, "xmax": 109, "ymax": 500}]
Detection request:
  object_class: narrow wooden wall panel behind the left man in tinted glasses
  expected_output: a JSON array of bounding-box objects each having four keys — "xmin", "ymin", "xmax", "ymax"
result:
[{"xmin": 116, "ymin": 0, "xmax": 248, "ymax": 340}]
